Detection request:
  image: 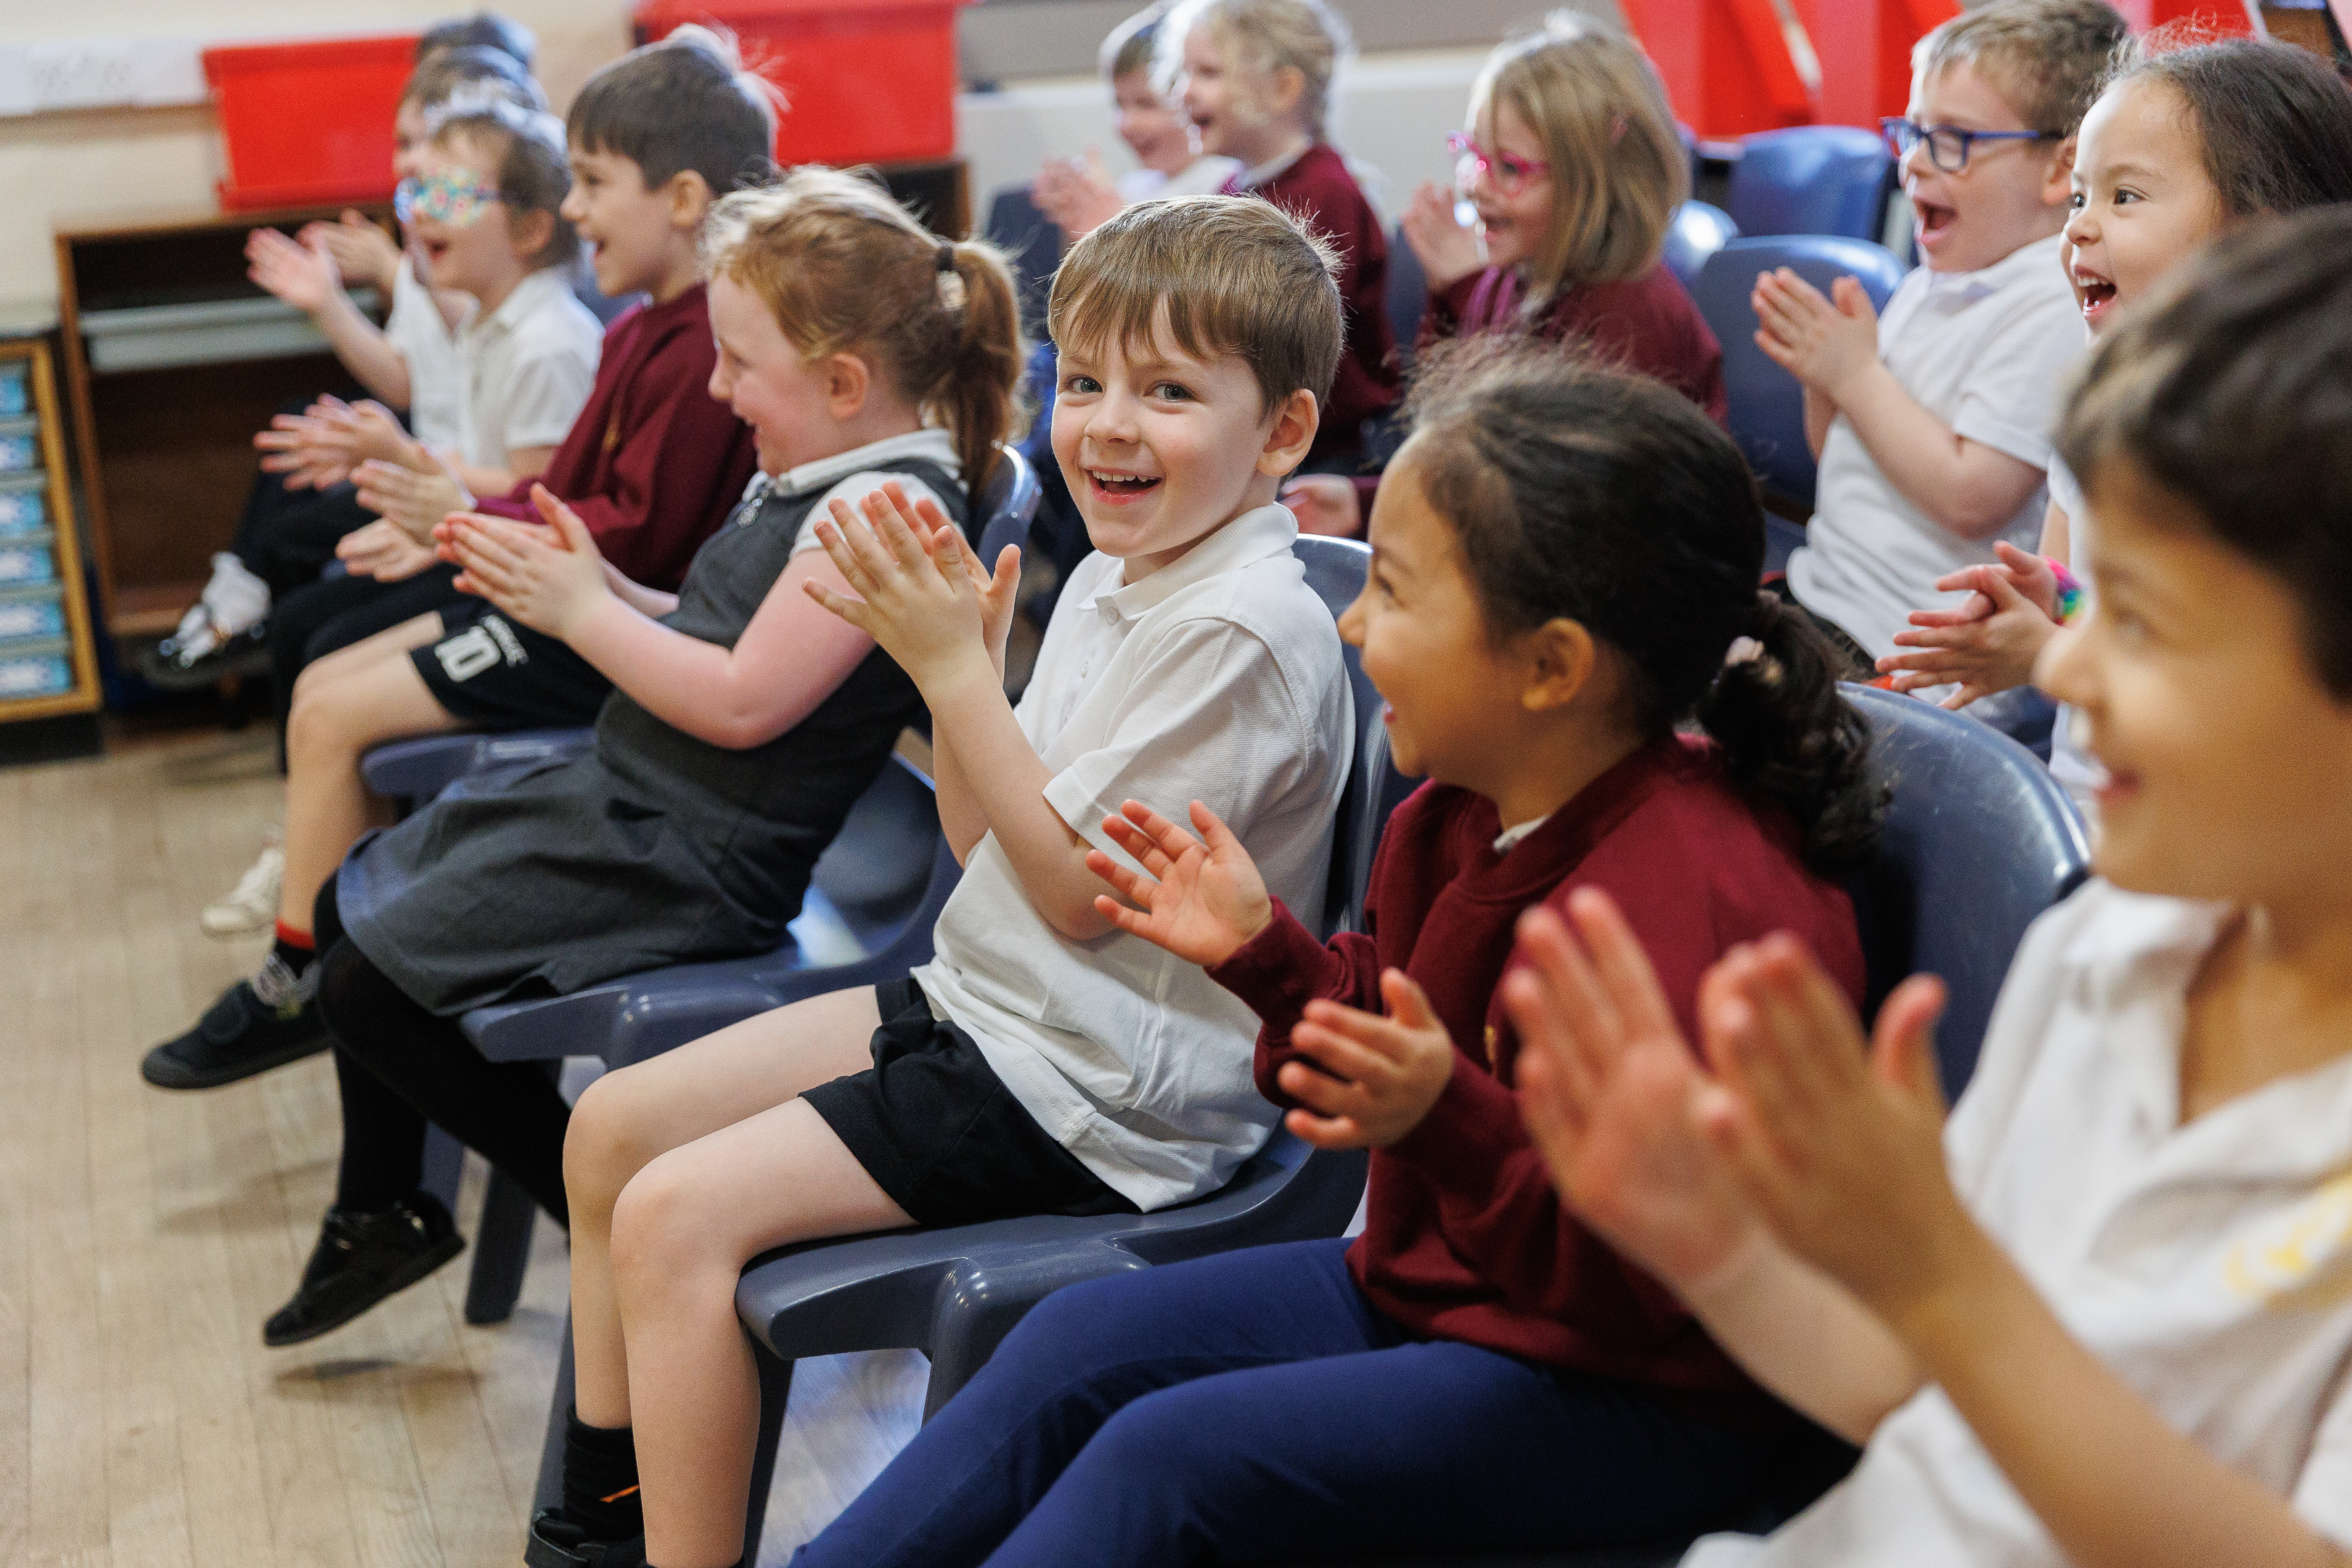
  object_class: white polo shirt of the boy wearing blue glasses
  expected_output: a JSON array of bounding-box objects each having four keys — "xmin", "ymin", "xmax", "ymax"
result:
[{"xmin": 1787, "ymin": 235, "xmax": 2084, "ymax": 658}]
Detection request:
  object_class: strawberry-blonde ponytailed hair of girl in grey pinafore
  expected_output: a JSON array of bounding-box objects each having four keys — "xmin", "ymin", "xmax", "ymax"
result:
[{"xmin": 701, "ymin": 165, "xmax": 1026, "ymax": 496}]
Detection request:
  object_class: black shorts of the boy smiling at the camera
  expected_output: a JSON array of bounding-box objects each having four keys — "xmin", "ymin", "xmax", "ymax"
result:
[{"xmin": 802, "ymin": 978, "xmax": 1138, "ymax": 1225}]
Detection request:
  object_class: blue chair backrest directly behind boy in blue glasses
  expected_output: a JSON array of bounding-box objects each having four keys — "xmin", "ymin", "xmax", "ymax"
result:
[{"xmin": 1691, "ymin": 235, "xmax": 1905, "ymax": 515}]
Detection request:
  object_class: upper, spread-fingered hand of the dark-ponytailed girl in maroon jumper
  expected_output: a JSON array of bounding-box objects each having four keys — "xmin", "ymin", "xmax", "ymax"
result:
[{"xmin": 1087, "ymin": 799, "xmax": 1275, "ymax": 968}]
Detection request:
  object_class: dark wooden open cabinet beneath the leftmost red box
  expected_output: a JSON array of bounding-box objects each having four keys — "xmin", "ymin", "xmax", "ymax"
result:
[{"xmin": 57, "ymin": 207, "xmax": 391, "ymax": 637}]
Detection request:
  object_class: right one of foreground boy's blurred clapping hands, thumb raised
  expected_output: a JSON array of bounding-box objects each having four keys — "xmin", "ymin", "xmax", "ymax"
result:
[{"xmin": 1701, "ymin": 936, "xmax": 1983, "ymax": 1338}]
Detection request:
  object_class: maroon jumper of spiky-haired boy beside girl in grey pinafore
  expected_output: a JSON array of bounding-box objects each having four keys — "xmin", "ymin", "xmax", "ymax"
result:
[{"xmin": 480, "ymin": 285, "xmax": 757, "ymax": 592}]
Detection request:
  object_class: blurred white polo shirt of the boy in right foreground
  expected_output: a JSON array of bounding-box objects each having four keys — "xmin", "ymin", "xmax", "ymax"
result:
[{"xmin": 1682, "ymin": 881, "xmax": 2352, "ymax": 1568}]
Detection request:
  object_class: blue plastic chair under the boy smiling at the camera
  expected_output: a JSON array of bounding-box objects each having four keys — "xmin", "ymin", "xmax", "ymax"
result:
[{"xmin": 539, "ymin": 536, "xmax": 1411, "ymax": 1561}]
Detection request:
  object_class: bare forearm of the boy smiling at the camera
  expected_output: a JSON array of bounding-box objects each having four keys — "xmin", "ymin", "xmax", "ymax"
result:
[{"xmin": 924, "ymin": 658, "xmax": 1113, "ymax": 943}]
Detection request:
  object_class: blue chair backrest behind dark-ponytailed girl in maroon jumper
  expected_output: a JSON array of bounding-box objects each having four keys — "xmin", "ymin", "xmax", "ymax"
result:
[{"xmin": 1844, "ymin": 687, "xmax": 2091, "ymax": 1095}]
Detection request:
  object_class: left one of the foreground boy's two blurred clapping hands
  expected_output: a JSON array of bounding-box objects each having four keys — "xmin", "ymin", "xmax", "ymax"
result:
[{"xmin": 1503, "ymin": 889, "xmax": 1762, "ymax": 1295}]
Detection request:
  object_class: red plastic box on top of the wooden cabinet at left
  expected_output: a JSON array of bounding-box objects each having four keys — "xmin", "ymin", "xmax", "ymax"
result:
[{"xmin": 205, "ymin": 33, "xmax": 416, "ymax": 211}]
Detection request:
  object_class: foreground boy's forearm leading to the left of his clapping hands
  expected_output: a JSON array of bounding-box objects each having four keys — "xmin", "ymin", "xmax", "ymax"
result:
[{"xmin": 1682, "ymin": 1232, "xmax": 1924, "ymax": 1446}]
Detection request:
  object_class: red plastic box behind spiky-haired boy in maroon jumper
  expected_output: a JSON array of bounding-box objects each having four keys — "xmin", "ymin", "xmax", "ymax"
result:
[{"xmin": 635, "ymin": 0, "xmax": 964, "ymax": 165}]
